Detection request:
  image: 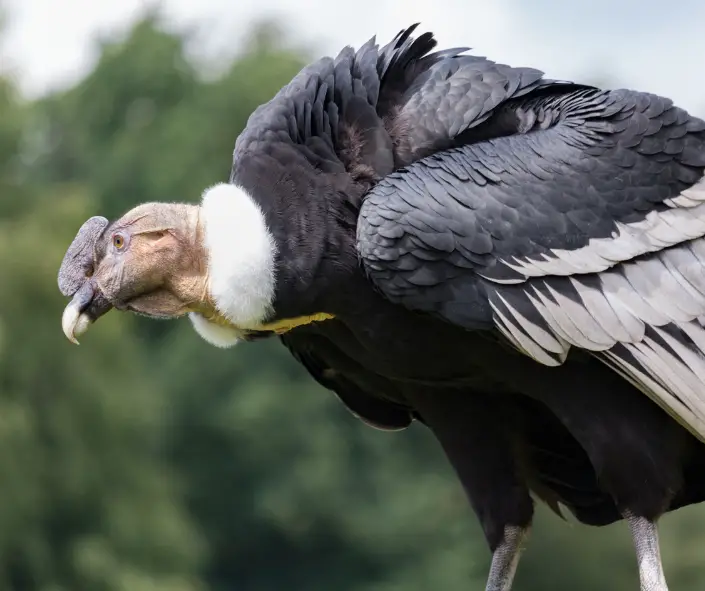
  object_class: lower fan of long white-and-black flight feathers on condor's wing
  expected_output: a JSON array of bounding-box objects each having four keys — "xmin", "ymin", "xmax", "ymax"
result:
[{"xmin": 489, "ymin": 237, "xmax": 705, "ymax": 441}]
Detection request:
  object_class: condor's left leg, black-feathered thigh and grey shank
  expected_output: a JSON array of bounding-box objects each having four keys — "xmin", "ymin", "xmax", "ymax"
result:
[{"xmin": 411, "ymin": 392, "xmax": 534, "ymax": 591}]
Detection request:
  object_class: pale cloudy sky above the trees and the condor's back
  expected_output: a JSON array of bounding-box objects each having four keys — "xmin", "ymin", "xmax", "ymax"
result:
[{"xmin": 0, "ymin": 0, "xmax": 705, "ymax": 115}]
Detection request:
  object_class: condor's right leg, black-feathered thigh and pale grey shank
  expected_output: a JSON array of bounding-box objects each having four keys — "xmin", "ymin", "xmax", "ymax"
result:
[{"xmin": 515, "ymin": 360, "xmax": 687, "ymax": 591}]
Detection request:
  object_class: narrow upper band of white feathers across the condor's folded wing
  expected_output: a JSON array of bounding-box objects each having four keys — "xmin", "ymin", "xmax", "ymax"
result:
[{"xmin": 485, "ymin": 177, "xmax": 705, "ymax": 283}]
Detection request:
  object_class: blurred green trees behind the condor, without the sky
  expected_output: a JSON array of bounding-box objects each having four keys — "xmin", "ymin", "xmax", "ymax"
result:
[{"xmin": 0, "ymin": 10, "xmax": 705, "ymax": 591}]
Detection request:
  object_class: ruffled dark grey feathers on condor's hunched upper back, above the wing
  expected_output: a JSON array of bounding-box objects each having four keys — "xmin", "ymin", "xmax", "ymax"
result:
[{"xmin": 233, "ymin": 25, "xmax": 588, "ymax": 187}]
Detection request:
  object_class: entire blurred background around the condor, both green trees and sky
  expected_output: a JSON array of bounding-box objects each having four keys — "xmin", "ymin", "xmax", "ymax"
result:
[{"xmin": 0, "ymin": 0, "xmax": 705, "ymax": 591}]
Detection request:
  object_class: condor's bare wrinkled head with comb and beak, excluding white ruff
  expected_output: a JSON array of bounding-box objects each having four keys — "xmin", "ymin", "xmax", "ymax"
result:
[{"xmin": 59, "ymin": 203, "xmax": 208, "ymax": 343}]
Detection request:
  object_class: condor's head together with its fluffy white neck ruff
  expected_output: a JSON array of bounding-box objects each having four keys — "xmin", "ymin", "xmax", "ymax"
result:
[{"xmin": 58, "ymin": 184, "xmax": 275, "ymax": 347}]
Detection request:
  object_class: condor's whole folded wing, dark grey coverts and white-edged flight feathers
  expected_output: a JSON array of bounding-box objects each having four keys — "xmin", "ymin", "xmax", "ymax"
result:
[{"xmin": 358, "ymin": 90, "xmax": 705, "ymax": 440}]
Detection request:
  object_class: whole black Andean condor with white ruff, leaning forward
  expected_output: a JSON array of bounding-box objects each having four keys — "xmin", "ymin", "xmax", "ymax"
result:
[{"xmin": 59, "ymin": 26, "xmax": 705, "ymax": 591}]
